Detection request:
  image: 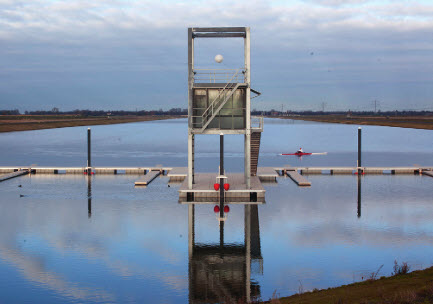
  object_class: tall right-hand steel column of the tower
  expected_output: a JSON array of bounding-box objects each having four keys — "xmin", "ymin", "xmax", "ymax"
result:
[{"xmin": 244, "ymin": 27, "xmax": 251, "ymax": 189}]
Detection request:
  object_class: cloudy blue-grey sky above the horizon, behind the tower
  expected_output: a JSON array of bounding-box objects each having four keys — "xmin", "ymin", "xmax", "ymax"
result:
[{"xmin": 0, "ymin": 0, "xmax": 433, "ymax": 112}]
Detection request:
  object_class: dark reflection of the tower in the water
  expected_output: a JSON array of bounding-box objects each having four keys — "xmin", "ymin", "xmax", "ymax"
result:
[{"xmin": 188, "ymin": 204, "xmax": 263, "ymax": 303}]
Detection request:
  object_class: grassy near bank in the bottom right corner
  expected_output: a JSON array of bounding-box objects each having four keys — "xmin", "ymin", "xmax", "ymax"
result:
[{"xmin": 266, "ymin": 267, "xmax": 433, "ymax": 304}]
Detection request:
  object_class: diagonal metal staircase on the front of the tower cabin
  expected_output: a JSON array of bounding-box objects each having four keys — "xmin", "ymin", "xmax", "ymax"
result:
[{"xmin": 201, "ymin": 71, "xmax": 245, "ymax": 132}]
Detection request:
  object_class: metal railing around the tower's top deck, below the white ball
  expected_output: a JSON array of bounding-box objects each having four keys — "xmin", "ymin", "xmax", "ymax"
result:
[{"xmin": 194, "ymin": 69, "xmax": 245, "ymax": 83}]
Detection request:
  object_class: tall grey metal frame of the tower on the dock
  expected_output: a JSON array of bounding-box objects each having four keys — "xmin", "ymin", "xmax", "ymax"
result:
[{"xmin": 187, "ymin": 27, "xmax": 255, "ymax": 189}]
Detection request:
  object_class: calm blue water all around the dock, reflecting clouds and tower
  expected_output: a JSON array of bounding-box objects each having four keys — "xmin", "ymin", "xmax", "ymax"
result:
[{"xmin": 0, "ymin": 120, "xmax": 433, "ymax": 303}]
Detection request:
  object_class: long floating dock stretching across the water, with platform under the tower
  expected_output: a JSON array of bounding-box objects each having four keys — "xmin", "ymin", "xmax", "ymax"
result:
[{"xmin": 0, "ymin": 165, "xmax": 433, "ymax": 190}]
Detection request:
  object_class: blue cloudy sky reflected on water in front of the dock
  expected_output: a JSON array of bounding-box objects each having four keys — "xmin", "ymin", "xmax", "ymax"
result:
[{"xmin": 0, "ymin": 175, "xmax": 433, "ymax": 303}]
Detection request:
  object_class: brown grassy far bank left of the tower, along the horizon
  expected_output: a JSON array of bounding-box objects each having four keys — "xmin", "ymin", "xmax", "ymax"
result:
[{"xmin": 0, "ymin": 115, "xmax": 180, "ymax": 132}]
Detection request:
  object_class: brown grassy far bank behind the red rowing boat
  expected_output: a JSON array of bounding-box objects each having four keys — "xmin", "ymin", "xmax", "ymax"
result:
[{"xmin": 270, "ymin": 114, "xmax": 433, "ymax": 130}]
